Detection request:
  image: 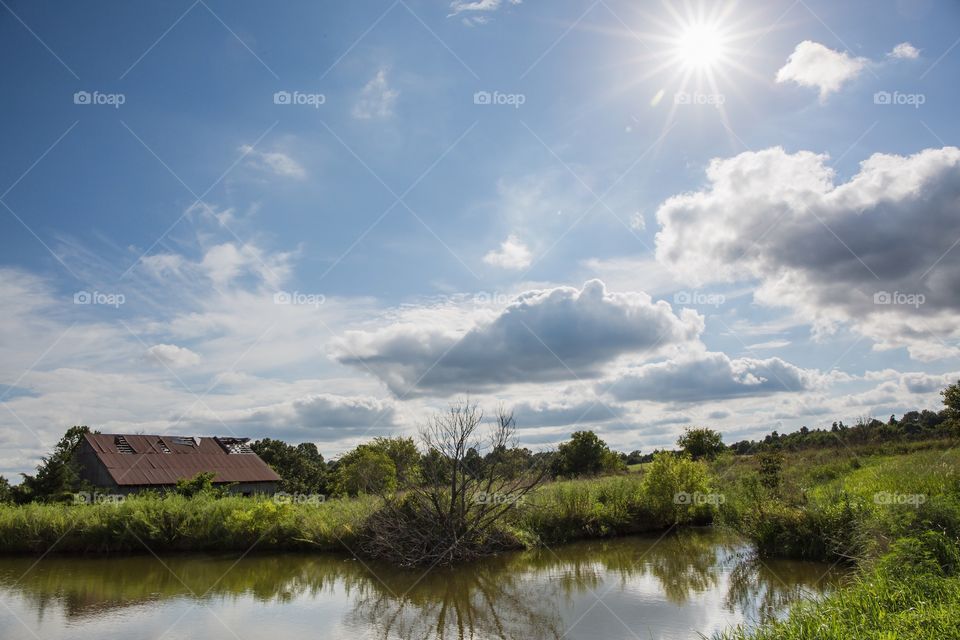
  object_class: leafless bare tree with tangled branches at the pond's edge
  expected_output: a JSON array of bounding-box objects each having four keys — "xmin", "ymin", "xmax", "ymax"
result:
[{"xmin": 363, "ymin": 400, "xmax": 547, "ymax": 566}]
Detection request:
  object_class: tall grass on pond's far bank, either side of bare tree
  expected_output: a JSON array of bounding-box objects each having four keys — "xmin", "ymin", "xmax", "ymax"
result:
[{"xmin": 0, "ymin": 457, "xmax": 712, "ymax": 554}]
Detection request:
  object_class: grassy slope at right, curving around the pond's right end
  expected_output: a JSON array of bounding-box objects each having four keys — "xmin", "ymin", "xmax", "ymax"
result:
[{"xmin": 714, "ymin": 443, "xmax": 960, "ymax": 640}]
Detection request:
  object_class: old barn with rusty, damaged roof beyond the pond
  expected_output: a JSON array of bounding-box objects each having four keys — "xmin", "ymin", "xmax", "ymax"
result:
[{"xmin": 74, "ymin": 433, "xmax": 280, "ymax": 495}]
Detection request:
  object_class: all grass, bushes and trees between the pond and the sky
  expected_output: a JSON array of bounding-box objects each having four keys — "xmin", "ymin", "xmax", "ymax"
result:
[{"xmin": 0, "ymin": 383, "xmax": 960, "ymax": 640}]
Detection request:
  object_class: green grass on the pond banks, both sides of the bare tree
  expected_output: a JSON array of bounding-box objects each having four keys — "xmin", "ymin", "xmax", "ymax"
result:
[{"xmin": 0, "ymin": 445, "xmax": 960, "ymax": 640}]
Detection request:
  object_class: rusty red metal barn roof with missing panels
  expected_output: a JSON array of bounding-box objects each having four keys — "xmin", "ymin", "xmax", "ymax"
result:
[{"xmin": 84, "ymin": 433, "xmax": 280, "ymax": 486}]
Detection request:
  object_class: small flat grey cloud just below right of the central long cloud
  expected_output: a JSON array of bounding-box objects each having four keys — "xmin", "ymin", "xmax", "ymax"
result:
[{"xmin": 598, "ymin": 352, "xmax": 825, "ymax": 402}]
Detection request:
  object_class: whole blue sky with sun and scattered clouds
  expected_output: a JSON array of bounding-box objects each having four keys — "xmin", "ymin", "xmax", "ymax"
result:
[{"xmin": 0, "ymin": 0, "xmax": 960, "ymax": 479}]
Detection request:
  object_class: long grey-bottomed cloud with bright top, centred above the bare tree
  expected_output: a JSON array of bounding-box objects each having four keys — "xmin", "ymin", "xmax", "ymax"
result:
[{"xmin": 336, "ymin": 280, "xmax": 703, "ymax": 395}]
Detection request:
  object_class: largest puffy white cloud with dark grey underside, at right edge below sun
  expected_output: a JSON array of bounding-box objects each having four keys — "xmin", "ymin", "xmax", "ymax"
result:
[{"xmin": 656, "ymin": 147, "xmax": 960, "ymax": 360}]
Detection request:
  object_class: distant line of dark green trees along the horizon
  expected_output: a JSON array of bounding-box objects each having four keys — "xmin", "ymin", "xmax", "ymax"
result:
[{"xmin": 0, "ymin": 381, "xmax": 960, "ymax": 504}]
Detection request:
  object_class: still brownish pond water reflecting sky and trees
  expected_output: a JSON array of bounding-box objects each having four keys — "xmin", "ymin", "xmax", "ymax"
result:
[{"xmin": 0, "ymin": 529, "xmax": 842, "ymax": 640}]
